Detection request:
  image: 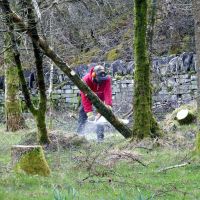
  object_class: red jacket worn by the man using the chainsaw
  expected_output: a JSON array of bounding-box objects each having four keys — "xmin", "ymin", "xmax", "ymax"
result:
[{"xmin": 81, "ymin": 67, "xmax": 112, "ymax": 113}]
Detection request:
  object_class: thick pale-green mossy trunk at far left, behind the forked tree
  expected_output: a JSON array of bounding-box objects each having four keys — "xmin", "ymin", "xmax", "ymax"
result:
[{"xmin": 4, "ymin": 33, "xmax": 25, "ymax": 131}]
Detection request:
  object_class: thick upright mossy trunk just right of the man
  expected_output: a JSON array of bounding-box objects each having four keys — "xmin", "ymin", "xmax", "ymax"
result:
[{"xmin": 133, "ymin": 0, "xmax": 161, "ymax": 139}]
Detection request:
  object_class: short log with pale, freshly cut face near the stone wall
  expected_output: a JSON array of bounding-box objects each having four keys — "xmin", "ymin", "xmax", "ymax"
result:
[{"xmin": 176, "ymin": 109, "xmax": 195, "ymax": 125}]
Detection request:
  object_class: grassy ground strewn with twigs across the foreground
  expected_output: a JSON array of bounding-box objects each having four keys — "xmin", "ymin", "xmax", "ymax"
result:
[{"xmin": 0, "ymin": 112, "xmax": 200, "ymax": 200}]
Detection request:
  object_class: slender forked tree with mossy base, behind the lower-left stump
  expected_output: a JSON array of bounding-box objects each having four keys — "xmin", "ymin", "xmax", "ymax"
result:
[{"xmin": 0, "ymin": 1, "xmax": 50, "ymax": 144}]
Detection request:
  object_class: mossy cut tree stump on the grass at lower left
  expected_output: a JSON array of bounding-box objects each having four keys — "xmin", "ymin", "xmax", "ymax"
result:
[{"xmin": 11, "ymin": 145, "xmax": 50, "ymax": 176}]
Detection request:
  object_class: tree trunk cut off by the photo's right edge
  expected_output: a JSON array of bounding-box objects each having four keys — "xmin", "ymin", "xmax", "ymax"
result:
[{"xmin": 192, "ymin": 0, "xmax": 200, "ymax": 153}]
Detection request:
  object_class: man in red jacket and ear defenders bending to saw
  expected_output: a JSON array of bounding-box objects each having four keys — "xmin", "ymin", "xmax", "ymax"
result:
[{"xmin": 77, "ymin": 65, "xmax": 112, "ymax": 141}]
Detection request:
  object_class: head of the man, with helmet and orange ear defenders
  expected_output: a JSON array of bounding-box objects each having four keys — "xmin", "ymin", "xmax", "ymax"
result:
[{"xmin": 92, "ymin": 65, "xmax": 108, "ymax": 83}]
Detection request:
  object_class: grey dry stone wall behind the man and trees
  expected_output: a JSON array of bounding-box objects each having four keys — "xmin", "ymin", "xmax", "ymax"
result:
[{"xmin": 0, "ymin": 53, "xmax": 197, "ymax": 117}]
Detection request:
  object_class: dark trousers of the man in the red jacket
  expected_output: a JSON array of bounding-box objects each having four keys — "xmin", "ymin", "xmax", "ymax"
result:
[{"xmin": 77, "ymin": 105, "xmax": 104, "ymax": 140}]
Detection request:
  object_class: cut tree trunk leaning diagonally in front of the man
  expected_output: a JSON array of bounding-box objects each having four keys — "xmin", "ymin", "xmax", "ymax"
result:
[{"xmin": 0, "ymin": 0, "xmax": 133, "ymax": 138}]
